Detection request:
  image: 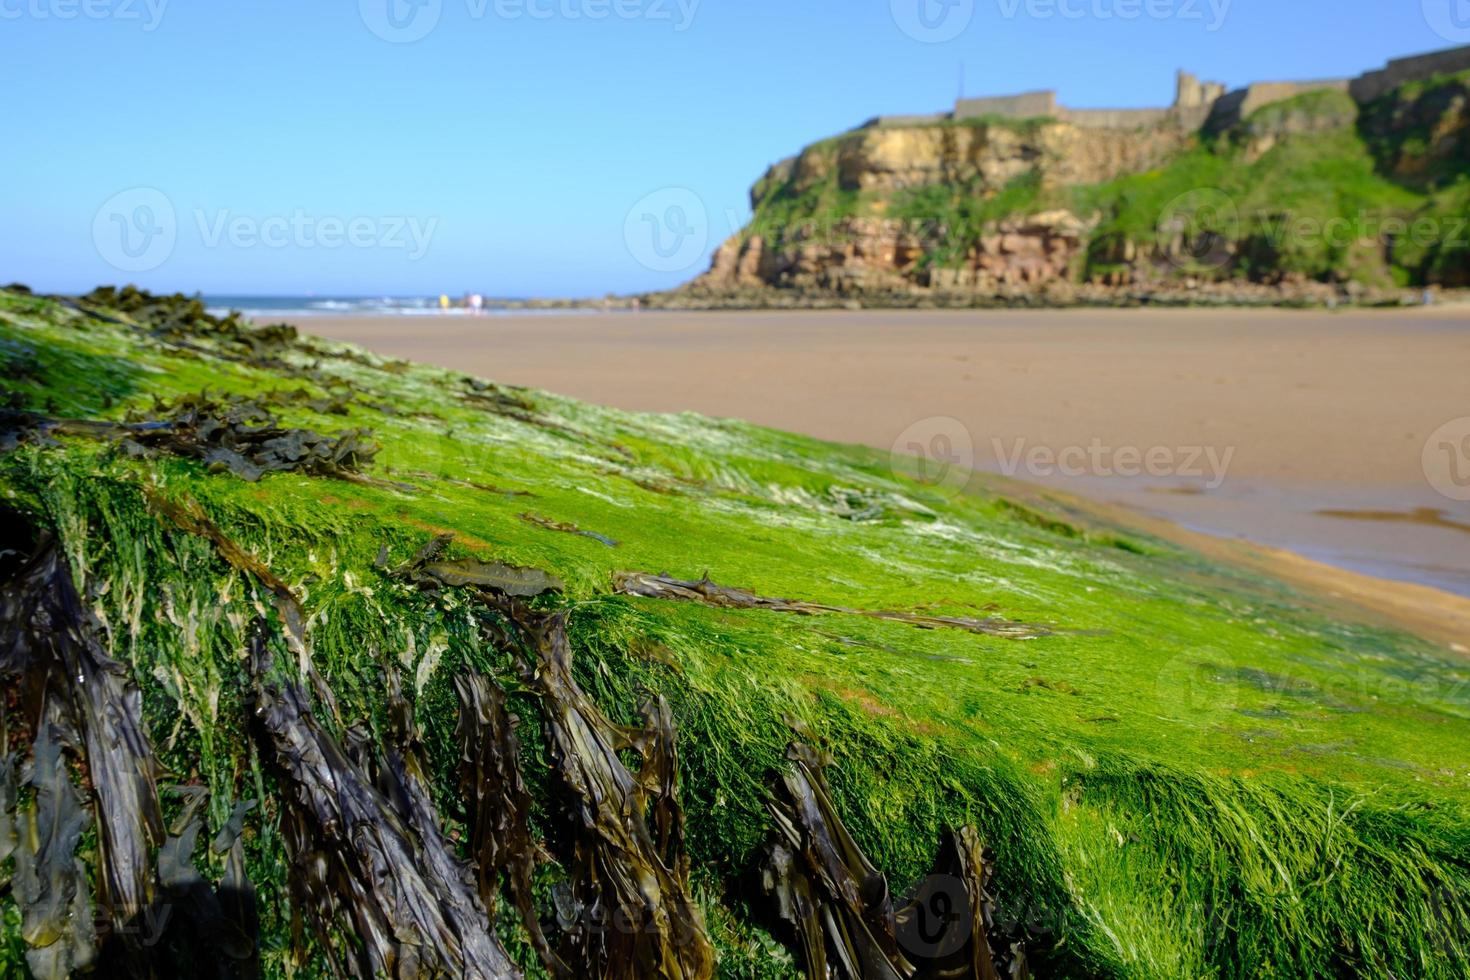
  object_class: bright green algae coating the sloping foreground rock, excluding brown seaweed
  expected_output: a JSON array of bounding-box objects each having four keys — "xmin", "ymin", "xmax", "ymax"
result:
[{"xmin": 0, "ymin": 292, "xmax": 1470, "ymax": 979}]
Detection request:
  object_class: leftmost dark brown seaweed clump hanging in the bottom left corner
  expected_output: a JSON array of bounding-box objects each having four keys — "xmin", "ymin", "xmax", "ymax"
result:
[{"xmin": 0, "ymin": 528, "xmax": 259, "ymax": 980}]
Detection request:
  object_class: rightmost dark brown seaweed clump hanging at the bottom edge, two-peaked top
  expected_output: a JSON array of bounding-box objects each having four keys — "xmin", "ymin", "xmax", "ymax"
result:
[{"xmin": 760, "ymin": 743, "xmax": 1028, "ymax": 980}]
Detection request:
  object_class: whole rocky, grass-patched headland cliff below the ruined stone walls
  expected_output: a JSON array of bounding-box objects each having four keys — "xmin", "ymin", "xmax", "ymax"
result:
[{"xmin": 682, "ymin": 75, "xmax": 1470, "ymax": 298}]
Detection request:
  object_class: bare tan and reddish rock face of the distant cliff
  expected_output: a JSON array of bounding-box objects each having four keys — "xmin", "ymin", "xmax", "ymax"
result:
[{"xmin": 694, "ymin": 122, "xmax": 1189, "ymax": 292}]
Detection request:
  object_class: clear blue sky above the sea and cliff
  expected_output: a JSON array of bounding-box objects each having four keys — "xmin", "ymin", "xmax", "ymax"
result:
[{"xmin": 0, "ymin": 0, "xmax": 1446, "ymax": 295}]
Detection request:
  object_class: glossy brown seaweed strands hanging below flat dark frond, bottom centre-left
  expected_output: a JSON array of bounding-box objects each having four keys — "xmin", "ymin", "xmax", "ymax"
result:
[{"xmin": 378, "ymin": 536, "xmax": 714, "ymax": 980}]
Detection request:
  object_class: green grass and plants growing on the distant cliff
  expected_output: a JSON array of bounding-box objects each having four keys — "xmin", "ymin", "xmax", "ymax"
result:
[{"xmin": 745, "ymin": 72, "xmax": 1470, "ymax": 287}]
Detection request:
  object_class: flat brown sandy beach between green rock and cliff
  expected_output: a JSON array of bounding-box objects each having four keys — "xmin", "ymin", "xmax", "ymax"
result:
[{"xmin": 297, "ymin": 309, "xmax": 1470, "ymax": 617}]
